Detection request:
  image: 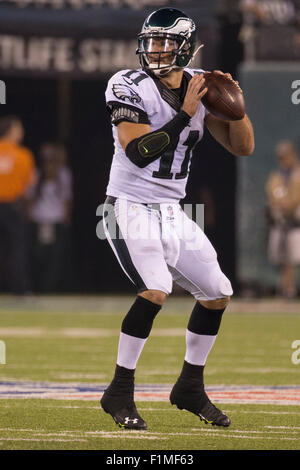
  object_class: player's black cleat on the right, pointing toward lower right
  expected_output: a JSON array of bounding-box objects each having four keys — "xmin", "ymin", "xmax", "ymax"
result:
[{"xmin": 170, "ymin": 379, "xmax": 230, "ymax": 427}]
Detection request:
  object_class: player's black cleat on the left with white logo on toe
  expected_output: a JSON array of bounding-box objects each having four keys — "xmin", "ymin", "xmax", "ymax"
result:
[{"xmin": 100, "ymin": 390, "xmax": 147, "ymax": 431}]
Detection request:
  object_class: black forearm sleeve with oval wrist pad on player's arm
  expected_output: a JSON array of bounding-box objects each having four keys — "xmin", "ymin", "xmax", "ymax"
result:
[{"xmin": 125, "ymin": 110, "xmax": 191, "ymax": 168}]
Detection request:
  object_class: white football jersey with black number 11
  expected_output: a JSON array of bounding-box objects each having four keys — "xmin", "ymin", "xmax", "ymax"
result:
[{"xmin": 105, "ymin": 68, "xmax": 207, "ymax": 203}]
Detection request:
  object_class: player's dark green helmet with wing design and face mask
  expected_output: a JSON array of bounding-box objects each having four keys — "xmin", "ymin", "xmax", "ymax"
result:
[{"xmin": 136, "ymin": 8, "xmax": 196, "ymax": 76}]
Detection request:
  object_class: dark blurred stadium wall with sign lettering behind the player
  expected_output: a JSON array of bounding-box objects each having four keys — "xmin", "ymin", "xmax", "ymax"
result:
[{"xmin": 0, "ymin": 0, "xmax": 300, "ymax": 296}]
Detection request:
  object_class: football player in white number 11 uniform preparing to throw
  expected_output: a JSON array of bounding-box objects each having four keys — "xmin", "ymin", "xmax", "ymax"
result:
[{"xmin": 101, "ymin": 8, "xmax": 254, "ymax": 430}]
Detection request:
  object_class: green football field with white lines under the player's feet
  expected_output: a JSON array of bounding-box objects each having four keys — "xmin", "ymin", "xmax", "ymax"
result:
[{"xmin": 0, "ymin": 296, "xmax": 300, "ymax": 450}]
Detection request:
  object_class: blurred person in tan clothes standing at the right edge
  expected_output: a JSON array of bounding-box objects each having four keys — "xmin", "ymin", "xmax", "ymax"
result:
[{"xmin": 266, "ymin": 140, "xmax": 300, "ymax": 298}]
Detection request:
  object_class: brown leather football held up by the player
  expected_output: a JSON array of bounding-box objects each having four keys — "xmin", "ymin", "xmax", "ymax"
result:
[{"xmin": 202, "ymin": 72, "xmax": 245, "ymax": 121}]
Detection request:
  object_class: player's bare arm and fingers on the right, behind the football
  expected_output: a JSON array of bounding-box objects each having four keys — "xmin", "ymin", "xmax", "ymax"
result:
[{"xmin": 204, "ymin": 70, "xmax": 255, "ymax": 157}]
